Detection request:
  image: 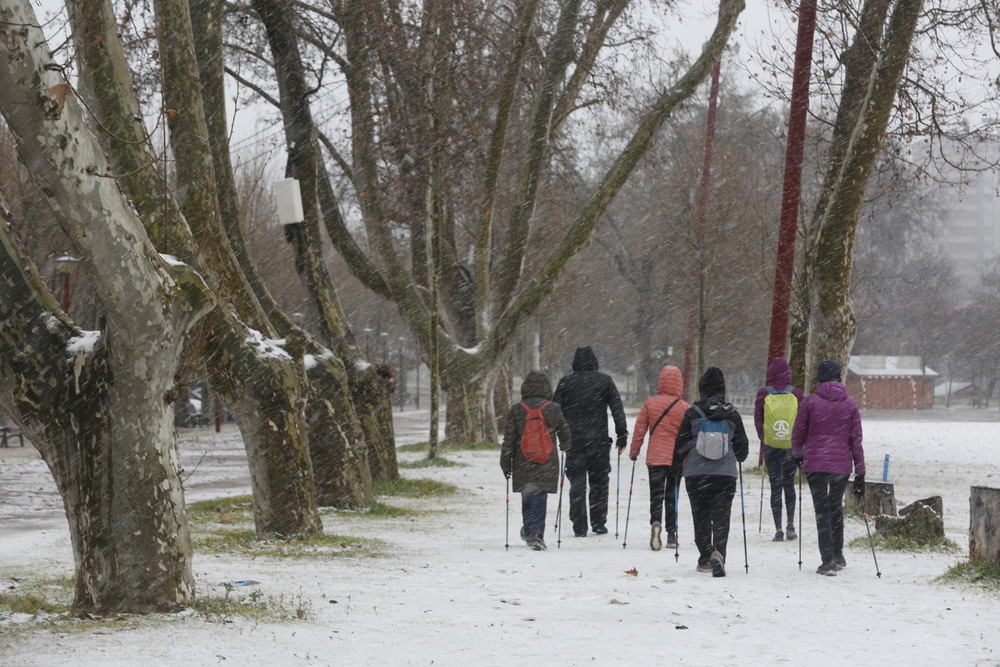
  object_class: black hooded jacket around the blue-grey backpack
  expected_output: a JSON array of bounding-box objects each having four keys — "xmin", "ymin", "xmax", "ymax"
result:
[{"xmin": 674, "ymin": 366, "xmax": 750, "ymax": 477}]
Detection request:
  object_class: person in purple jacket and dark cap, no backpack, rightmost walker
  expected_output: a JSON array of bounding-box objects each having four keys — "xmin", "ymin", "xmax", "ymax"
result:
[{"xmin": 792, "ymin": 359, "xmax": 865, "ymax": 577}]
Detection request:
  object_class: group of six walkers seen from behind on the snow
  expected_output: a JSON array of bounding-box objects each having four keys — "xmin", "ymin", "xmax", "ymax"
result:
[{"xmin": 500, "ymin": 346, "xmax": 865, "ymax": 577}]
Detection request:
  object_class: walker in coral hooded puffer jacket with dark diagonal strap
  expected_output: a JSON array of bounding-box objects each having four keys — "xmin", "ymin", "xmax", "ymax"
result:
[{"xmin": 628, "ymin": 366, "xmax": 691, "ymax": 551}]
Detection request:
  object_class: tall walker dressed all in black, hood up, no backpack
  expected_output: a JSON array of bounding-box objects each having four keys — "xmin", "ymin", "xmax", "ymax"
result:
[{"xmin": 552, "ymin": 345, "xmax": 628, "ymax": 537}]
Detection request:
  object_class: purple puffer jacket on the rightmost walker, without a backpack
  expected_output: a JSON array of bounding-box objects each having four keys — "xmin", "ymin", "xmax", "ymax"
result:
[{"xmin": 792, "ymin": 382, "xmax": 865, "ymax": 475}]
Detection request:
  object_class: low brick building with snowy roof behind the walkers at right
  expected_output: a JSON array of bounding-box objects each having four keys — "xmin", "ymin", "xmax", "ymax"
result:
[{"xmin": 844, "ymin": 355, "xmax": 938, "ymax": 410}]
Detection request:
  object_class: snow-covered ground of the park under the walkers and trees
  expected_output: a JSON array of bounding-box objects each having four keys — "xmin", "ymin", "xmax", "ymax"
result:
[{"xmin": 0, "ymin": 411, "xmax": 1000, "ymax": 667}]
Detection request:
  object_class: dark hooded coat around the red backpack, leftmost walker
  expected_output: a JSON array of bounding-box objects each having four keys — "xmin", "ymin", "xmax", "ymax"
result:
[{"xmin": 500, "ymin": 371, "xmax": 572, "ymax": 493}]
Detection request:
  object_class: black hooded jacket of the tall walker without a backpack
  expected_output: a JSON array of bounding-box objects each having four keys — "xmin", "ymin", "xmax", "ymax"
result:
[{"xmin": 552, "ymin": 345, "xmax": 628, "ymax": 452}]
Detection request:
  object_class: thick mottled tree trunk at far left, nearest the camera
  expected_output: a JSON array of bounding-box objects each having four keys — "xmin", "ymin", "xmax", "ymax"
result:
[{"xmin": 0, "ymin": 0, "xmax": 213, "ymax": 611}]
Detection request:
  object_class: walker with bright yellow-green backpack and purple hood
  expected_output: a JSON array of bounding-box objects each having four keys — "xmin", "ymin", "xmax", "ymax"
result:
[{"xmin": 753, "ymin": 357, "xmax": 804, "ymax": 542}]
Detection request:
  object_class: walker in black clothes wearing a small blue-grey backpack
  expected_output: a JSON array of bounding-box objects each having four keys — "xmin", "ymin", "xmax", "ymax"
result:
[{"xmin": 673, "ymin": 366, "xmax": 750, "ymax": 577}]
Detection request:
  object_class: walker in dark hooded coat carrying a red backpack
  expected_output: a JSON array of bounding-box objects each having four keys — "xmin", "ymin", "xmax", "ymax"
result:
[{"xmin": 500, "ymin": 371, "xmax": 571, "ymax": 551}]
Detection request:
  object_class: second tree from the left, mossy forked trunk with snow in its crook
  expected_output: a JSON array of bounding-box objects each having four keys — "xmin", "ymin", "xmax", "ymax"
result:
[{"xmin": 70, "ymin": 0, "xmax": 322, "ymax": 534}]
